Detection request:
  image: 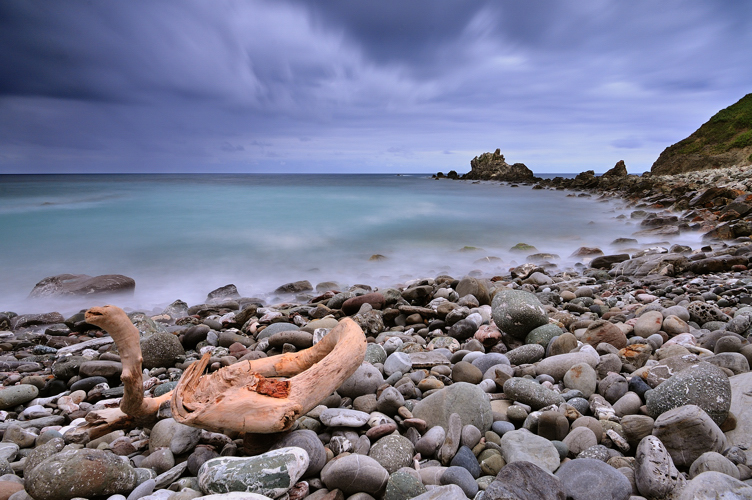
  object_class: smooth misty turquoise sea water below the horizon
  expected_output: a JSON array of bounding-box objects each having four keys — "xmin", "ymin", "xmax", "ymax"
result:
[{"xmin": 0, "ymin": 174, "xmax": 704, "ymax": 313}]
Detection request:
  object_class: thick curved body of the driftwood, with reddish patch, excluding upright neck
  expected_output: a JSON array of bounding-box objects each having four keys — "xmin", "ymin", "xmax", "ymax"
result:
[{"xmin": 172, "ymin": 318, "xmax": 366, "ymax": 434}]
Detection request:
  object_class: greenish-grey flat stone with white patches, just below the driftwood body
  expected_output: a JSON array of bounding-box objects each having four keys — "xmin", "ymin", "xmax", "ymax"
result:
[{"xmin": 198, "ymin": 446, "xmax": 308, "ymax": 498}]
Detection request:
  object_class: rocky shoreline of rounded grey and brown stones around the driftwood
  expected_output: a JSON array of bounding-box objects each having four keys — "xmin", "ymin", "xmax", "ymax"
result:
[{"xmin": 0, "ymin": 169, "xmax": 752, "ymax": 500}]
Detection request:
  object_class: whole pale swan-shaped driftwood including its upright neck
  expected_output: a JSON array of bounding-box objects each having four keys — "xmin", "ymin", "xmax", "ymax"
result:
[{"xmin": 66, "ymin": 306, "xmax": 366, "ymax": 441}]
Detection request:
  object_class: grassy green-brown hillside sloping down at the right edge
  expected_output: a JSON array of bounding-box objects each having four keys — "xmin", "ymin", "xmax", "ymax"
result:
[{"xmin": 650, "ymin": 94, "xmax": 752, "ymax": 175}]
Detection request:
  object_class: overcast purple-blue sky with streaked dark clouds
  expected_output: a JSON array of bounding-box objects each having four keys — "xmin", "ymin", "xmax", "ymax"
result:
[{"xmin": 0, "ymin": 0, "xmax": 752, "ymax": 173}]
